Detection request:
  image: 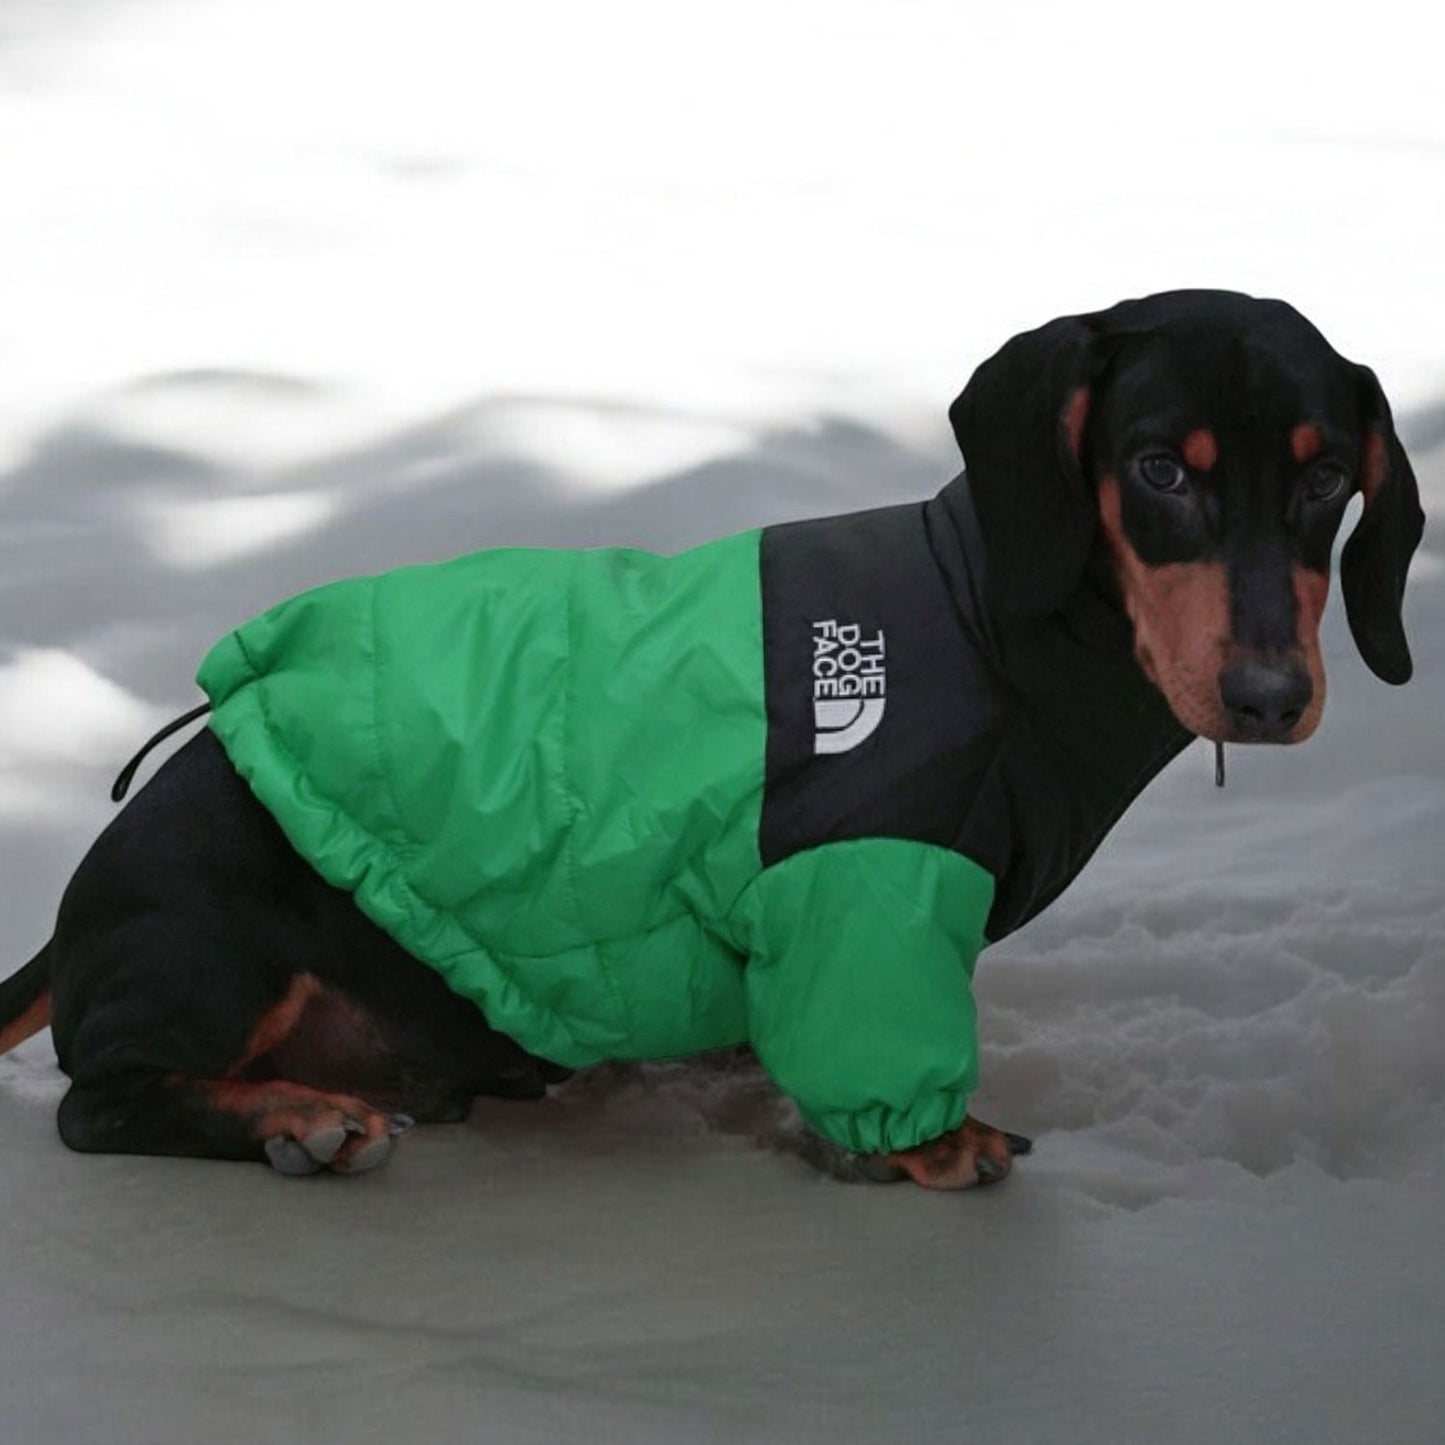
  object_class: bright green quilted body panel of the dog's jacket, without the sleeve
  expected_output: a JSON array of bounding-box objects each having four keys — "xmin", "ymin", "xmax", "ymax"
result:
[{"xmin": 199, "ymin": 533, "xmax": 766, "ymax": 1066}]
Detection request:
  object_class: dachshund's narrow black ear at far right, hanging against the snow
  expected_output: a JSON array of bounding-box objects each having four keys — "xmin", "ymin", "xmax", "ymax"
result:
[{"xmin": 1340, "ymin": 366, "xmax": 1425, "ymax": 682}]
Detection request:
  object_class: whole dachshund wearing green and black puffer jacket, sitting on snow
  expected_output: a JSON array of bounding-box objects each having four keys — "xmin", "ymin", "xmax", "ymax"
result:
[{"xmin": 0, "ymin": 290, "xmax": 1423, "ymax": 1188}]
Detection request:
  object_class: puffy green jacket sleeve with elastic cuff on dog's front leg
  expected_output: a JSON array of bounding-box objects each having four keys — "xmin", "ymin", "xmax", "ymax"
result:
[{"xmin": 734, "ymin": 838, "xmax": 994, "ymax": 1153}]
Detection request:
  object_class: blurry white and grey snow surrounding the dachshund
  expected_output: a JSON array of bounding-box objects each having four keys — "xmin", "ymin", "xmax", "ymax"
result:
[{"xmin": 0, "ymin": 0, "xmax": 1445, "ymax": 1445}]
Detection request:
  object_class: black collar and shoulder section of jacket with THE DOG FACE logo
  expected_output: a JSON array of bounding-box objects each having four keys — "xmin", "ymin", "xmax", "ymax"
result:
[{"xmin": 759, "ymin": 477, "xmax": 1189, "ymax": 941}]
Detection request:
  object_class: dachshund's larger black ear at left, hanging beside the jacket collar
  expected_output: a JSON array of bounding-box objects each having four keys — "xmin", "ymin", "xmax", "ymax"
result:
[{"xmin": 948, "ymin": 316, "xmax": 1103, "ymax": 617}]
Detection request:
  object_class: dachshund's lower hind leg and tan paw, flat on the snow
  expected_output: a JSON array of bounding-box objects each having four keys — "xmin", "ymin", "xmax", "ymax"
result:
[{"xmin": 59, "ymin": 1072, "xmax": 412, "ymax": 1175}]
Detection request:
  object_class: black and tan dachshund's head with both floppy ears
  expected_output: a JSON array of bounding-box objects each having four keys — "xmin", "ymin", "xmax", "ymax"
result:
[{"xmin": 949, "ymin": 290, "xmax": 1423, "ymax": 743}]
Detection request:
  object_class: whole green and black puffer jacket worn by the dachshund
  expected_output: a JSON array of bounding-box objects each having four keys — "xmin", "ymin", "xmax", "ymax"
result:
[{"xmin": 199, "ymin": 478, "xmax": 1186, "ymax": 1153}]
